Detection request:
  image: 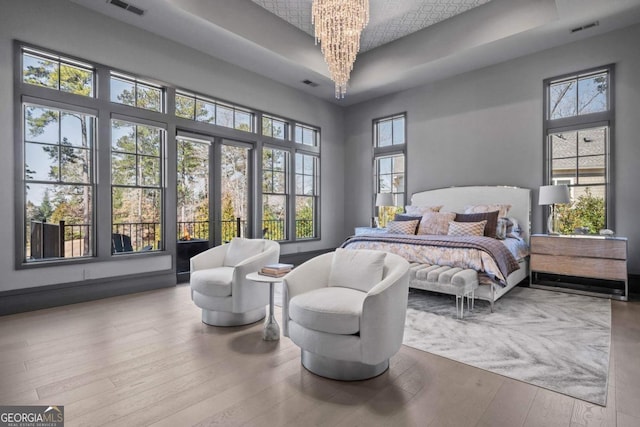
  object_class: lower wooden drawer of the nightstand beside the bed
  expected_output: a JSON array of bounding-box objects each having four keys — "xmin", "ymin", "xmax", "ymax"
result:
[{"xmin": 530, "ymin": 254, "xmax": 627, "ymax": 281}]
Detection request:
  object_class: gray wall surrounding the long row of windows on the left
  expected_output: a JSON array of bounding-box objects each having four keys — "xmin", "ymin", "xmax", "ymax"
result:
[{"xmin": 0, "ymin": 0, "xmax": 344, "ymax": 291}]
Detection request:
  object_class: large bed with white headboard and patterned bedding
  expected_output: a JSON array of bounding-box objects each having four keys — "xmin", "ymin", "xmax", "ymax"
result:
[{"xmin": 342, "ymin": 186, "xmax": 531, "ymax": 310}]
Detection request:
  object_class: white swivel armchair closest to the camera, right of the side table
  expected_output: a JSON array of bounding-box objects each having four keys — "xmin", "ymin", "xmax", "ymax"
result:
[{"xmin": 282, "ymin": 249, "xmax": 409, "ymax": 381}]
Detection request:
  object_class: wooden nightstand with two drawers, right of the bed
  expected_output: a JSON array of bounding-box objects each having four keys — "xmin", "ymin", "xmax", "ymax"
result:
[{"xmin": 529, "ymin": 234, "xmax": 629, "ymax": 301}]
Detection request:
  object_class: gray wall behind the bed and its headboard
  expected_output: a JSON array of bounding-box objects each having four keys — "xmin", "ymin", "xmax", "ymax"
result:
[{"xmin": 345, "ymin": 25, "xmax": 640, "ymax": 274}]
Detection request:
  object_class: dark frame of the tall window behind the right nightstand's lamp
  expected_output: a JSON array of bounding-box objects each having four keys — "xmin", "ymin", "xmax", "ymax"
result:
[{"xmin": 542, "ymin": 64, "xmax": 616, "ymax": 229}]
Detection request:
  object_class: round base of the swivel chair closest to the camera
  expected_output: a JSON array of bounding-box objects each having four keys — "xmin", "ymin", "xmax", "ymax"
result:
[{"xmin": 300, "ymin": 350, "xmax": 389, "ymax": 381}]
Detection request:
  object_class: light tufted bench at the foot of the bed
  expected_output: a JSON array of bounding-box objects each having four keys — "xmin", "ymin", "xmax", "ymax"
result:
[{"xmin": 409, "ymin": 263, "xmax": 478, "ymax": 318}]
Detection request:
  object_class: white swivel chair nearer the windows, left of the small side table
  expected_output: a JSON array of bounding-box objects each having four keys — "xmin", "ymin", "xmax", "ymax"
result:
[{"xmin": 190, "ymin": 238, "xmax": 280, "ymax": 326}]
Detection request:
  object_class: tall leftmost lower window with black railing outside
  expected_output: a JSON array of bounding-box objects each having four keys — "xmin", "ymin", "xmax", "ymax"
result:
[{"xmin": 23, "ymin": 104, "xmax": 96, "ymax": 261}]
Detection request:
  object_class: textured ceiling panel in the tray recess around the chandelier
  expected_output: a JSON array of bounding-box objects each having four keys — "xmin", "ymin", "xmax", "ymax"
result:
[{"xmin": 252, "ymin": 0, "xmax": 490, "ymax": 52}]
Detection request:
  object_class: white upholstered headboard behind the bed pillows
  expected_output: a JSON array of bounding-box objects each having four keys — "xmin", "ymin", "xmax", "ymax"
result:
[{"xmin": 411, "ymin": 186, "xmax": 531, "ymax": 243}]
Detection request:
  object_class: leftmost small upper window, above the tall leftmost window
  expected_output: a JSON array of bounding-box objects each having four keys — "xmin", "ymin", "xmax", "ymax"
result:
[{"xmin": 21, "ymin": 48, "xmax": 95, "ymax": 97}]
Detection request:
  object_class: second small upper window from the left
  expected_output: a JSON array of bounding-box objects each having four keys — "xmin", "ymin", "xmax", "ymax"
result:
[{"xmin": 111, "ymin": 73, "xmax": 164, "ymax": 112}]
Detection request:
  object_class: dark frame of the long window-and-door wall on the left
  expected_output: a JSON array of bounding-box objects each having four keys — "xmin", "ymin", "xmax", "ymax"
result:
[{"xmin": 13, "ymin": 40, "xmax": 322, "ymax": 270}]
